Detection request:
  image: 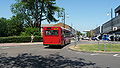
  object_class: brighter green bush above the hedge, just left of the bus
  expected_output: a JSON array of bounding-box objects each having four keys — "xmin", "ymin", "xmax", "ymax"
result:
[{"xmin": 21, "ymin": 27, "xmax": 41, "ymax": 36}]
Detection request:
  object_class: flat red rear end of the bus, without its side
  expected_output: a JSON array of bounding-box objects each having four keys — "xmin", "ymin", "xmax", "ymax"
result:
[{"xmin": 43, "ymin": 27, "xmax": 62, "ymax": 46}]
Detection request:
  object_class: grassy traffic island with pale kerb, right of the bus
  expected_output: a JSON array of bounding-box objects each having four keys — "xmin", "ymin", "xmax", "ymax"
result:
[{"xmin": 69, "ymin": 44, "xmax": 120, "ymax": 53}]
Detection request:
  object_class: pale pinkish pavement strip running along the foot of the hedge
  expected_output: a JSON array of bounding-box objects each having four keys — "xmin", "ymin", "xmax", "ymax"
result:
[{"xmin": 0, "ymin": 42, "xmax": 43, "ymax": 46}]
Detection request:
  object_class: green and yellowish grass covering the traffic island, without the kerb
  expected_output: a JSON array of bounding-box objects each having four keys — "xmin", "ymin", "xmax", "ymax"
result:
[{"xmin": 75, "ymin": 44, "xmax": 120, "ymax": 52}]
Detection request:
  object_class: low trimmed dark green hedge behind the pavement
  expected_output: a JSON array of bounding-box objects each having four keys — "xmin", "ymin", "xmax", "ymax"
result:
[{"xmin": 0, "ymin": 36, "xmax": 42, "ymax": 43}]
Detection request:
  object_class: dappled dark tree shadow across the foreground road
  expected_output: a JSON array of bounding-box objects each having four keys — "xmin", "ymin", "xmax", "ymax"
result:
[{"xmin": 0, "ymin": 53, "xmax": 95, "ymax": 68}]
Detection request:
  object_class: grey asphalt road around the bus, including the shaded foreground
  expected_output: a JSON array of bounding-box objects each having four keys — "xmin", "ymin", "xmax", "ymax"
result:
[{"xmin": 0, "ymin": 41, "xmax": 120, "ymax": 68}]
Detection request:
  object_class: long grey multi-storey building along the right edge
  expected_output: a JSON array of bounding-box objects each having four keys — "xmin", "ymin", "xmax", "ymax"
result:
[{"xmin": 94, "ymin": 6, "xmax": 120, "ymax": 35}]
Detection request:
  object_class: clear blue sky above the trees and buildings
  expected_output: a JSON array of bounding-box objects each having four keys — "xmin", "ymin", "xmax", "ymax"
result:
[{"xmin": 0, "ymin": 0, "xmax": 120, "ymax": 32}]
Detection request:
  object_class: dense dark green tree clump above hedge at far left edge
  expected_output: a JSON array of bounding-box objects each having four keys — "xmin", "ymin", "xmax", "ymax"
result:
[{"xmin": 0, "ymin": 16, "xmax": 23, "ymax": 37}]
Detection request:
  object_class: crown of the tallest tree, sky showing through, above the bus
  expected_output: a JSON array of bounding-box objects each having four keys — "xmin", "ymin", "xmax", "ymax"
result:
[{"xmin": 11, "ymin": 0, "xmax": 59, "ymax": 28}]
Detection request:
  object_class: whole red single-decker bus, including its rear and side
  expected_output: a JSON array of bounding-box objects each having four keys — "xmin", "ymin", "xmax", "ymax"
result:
[{"xmin": 43, "ymin": 27, "xmax": 71, "ymax": 46}]
